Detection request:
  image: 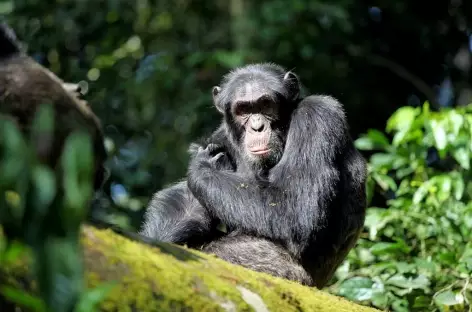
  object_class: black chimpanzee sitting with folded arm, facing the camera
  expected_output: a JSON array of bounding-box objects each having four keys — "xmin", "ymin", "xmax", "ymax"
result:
[{"xmin": 141, "ymin": 64, "xmax": 366, "ymax": 288}]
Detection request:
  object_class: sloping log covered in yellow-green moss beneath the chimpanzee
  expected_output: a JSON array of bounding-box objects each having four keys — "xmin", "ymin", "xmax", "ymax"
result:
[{"xmin": 0, "ymin": 225, "xmax": 377, "ymax": 312}]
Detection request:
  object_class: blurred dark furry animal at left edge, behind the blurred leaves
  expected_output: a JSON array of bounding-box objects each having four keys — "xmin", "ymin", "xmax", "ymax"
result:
[{"xmin": 0, "ymin": 22, "xmax": 107, "ymax": 189}]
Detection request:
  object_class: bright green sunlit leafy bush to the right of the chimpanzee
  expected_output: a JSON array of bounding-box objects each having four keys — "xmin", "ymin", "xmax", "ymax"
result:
[{"xmin": 331, "ymin": 103, "xmax": 472, "ymax": 312}]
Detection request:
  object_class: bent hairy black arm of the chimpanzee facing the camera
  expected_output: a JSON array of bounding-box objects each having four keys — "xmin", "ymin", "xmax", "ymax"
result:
[{"xmin": 188, "ymin": 96, "xmax": 353, "ymax": 253}]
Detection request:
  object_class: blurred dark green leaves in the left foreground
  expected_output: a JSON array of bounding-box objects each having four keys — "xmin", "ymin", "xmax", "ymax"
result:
[{"xmin": 0, "ymin": 104, "xmax": 112, "ymax": 312}]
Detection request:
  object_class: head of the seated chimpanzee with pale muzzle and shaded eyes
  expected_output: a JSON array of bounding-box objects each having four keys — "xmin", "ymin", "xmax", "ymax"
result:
[{"xmin": 212, "ymin": 64, "xmax": 300, "ymax": 168}]
